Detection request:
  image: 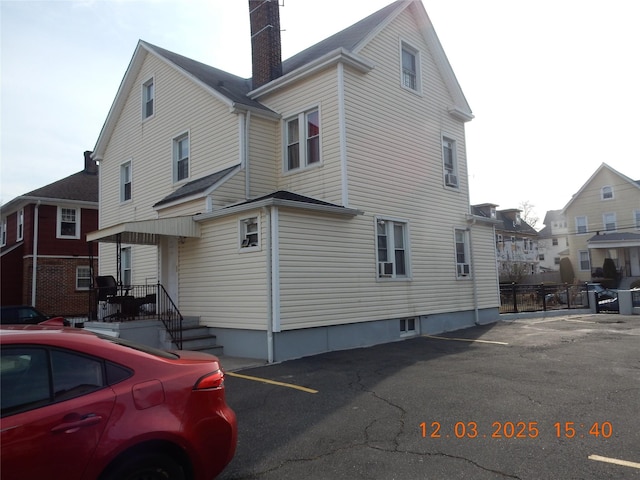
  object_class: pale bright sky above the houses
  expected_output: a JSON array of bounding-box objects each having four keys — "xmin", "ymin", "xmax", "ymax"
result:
[{"xmin": 0, "ymin": 0, "xmax": 640, "ymax": 229}]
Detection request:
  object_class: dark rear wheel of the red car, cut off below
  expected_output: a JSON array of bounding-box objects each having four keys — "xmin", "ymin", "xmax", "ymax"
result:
[{"xmin": 103, "ymin": 453, "xmax": 186, "ymax": 480}]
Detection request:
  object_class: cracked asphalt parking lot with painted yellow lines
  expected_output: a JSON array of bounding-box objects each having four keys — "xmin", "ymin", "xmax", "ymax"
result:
[{"xmin": 219, "ymin": 314, "xmax": 640, "ymax": 480}]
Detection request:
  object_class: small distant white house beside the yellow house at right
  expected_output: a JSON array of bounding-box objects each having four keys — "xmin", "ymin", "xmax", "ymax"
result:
[{"xmin": 538, "ymin": 210, "xmax": 569, "ymax": 272}]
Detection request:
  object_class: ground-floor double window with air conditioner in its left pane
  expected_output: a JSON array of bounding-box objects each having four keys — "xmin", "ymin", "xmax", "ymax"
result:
[{"xmin": 376, "ymin": 219, "xmax": 409, "ymax": 278}]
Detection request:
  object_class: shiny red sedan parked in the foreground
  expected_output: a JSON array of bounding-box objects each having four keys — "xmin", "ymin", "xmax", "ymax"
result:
[{"xmin": 0, "ymin": 325, "xmax": 237, "ymax": 480}]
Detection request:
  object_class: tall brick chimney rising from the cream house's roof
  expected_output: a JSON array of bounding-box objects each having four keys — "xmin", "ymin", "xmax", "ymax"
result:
[{"xmin": 249, "ymin": 0, "xmax": 282, "ymax": 88}]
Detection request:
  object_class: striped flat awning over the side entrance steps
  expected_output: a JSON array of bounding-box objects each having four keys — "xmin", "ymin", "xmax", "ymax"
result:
[{"xmin": 87, "ymin": 216, "xmax": 200, "ymax": 245}]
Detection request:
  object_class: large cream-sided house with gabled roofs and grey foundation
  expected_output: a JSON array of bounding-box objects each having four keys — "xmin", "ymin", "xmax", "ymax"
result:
[{"xmin": 88, "ymin": 0, "xmax": 499, "ymax": 361}]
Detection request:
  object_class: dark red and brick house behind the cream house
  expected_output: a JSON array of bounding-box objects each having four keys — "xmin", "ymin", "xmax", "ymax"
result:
[{"xmin": 0, "ymin": 152, "xmax": 98, "ymax": 316}]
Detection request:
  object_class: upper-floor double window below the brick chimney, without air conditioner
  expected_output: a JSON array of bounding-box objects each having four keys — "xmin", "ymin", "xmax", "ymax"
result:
[{"xmin": 285, "ymin": 109, "xmax": 320, "ymax": 171}]
